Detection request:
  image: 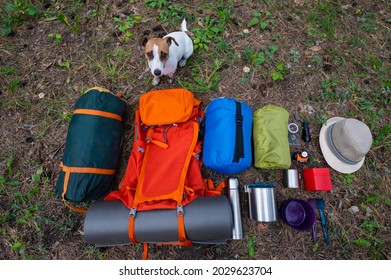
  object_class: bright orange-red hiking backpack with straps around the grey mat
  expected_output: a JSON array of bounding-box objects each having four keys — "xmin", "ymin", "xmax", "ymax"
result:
[{"xmin": 105, "ymin": 89, "xmax": 224, "ymax": 249}]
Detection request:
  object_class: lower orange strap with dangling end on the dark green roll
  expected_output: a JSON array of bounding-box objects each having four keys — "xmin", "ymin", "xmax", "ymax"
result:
[{"xmin": 60, "ymin": 163, "xmax": 116, "ymax": 214}]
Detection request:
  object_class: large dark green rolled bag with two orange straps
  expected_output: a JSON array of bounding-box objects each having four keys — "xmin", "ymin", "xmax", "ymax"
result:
[{"xmin": 56, "ymin": 87, "xmax": 126, "ymax": 212}]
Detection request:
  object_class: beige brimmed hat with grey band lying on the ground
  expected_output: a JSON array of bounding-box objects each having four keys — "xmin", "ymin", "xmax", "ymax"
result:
[{"xmin": 319, "ymin": 117, "xmax": 372, "ymax": 173}]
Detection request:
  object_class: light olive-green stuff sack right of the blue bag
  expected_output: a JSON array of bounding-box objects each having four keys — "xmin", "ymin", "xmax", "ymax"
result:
[{"xmin": 253, "ymin": 104, "xmax": 291, "ymax": 169}]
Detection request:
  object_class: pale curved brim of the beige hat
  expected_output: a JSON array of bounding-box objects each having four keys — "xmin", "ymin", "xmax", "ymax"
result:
[{"xmin": 319, "ymin": 117, "xmax": 365, "ymax": 174}]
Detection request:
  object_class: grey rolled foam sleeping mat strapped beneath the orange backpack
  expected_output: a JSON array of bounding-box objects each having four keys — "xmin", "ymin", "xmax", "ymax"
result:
[{"xmin": 84, "ymin": 196, "xmax": 233, "ymax": 247}]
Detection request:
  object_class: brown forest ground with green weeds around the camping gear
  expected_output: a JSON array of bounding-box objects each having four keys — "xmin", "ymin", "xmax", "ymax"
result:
[{"xmin": 0, "ymin": 0, "xmax": 391, "ymax": 259}]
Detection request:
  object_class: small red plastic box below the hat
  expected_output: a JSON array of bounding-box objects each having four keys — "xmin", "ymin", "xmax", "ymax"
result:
[{"xmin": 303, "ymin": 168, "xmax": 333, "ymax": 191}]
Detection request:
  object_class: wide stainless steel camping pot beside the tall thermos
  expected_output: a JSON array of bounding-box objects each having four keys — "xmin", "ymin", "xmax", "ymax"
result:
[{"xmin": 244, "ymin": 183, "xmax": 277, "ymax": 222}]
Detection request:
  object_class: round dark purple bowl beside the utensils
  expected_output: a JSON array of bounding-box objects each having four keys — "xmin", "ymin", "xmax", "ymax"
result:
[{"xmin": 281, "ymin": 199, "xmax": 315, "ymax": 231}]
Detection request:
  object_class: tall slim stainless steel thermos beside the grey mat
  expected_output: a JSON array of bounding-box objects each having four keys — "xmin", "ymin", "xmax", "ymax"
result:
[{"xmin": 228, "ymin": 178, "xmax": 243, "ymax": 239}]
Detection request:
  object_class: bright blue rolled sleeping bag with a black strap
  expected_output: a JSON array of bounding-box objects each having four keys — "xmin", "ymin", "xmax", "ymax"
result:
[{"xmin": 203, "ymin": 97, "xmax": 252, "ymax": 174}]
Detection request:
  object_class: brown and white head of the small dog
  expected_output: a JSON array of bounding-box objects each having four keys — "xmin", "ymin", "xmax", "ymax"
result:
[{"xmin": 140, "ymin": 37, "xmax": 178, "ymax": 77}]
